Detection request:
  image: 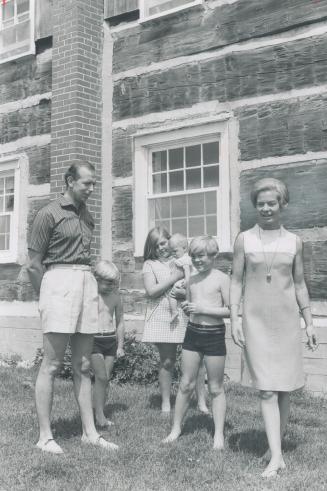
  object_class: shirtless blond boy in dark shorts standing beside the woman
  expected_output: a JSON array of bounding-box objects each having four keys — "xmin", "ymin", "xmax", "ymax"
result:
[{"xmin": 163, "ymin": 236, "xmax": 229, "ymax": 450}]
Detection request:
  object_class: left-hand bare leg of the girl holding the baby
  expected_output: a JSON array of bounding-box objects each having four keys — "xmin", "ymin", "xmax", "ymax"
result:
[{"xmin": 156, "ymin": 343, "xmax": 177, "ymax": 413}]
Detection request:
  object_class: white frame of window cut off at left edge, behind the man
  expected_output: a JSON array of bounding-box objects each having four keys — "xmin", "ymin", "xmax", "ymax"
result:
[{"xmin": 0, "ymin": 155, "xmax": 28, "ymax": 264}]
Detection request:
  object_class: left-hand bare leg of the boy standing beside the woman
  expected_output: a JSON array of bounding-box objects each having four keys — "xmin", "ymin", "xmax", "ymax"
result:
[{"xmin": 163, "ymin": 350, "xmax": 201, "ymax": 443}]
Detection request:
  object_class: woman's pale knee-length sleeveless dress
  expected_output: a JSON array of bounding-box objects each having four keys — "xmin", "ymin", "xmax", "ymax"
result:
[{"xmin": 242, "ymin": 225, "xmax": 304, "ymax": 392}]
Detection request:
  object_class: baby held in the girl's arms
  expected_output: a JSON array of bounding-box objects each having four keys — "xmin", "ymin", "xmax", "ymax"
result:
[{"xmin": 168, "ymin": 233, "xmax": 192, "ymax": 323}]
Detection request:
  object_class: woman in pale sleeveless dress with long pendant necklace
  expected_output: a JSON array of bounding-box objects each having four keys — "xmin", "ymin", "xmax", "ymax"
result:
[{"xmin": 230, "ymin": 178, "xmax": 317, "ymax": 477}]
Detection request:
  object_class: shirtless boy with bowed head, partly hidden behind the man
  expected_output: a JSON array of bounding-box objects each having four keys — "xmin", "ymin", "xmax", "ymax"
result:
[{"xmin": 91, "ymin": 260, "xmax": 125, "ymax": 428}]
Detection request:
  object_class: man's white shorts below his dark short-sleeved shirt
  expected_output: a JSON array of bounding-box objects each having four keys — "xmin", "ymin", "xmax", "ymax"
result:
[{"xmin": 39, "ymin": 264, "xmax": 99, "ymax": 334}]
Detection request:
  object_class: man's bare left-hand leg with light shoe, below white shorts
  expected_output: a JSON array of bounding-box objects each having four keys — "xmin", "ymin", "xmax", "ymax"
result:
[{"xmin": 35, "ymin": 333, "xmax": 69, "ymax": 453}]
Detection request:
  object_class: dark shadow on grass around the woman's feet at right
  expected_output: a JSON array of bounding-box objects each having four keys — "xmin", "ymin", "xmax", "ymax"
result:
[{"xmin": 228, "ymin": 430, "xmax": 298, "ymax": 457}]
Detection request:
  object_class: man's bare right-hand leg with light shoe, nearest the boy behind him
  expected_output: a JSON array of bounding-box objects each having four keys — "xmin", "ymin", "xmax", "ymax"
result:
[{"xmin": 71, "ymin": 333, "xmax": 118, "ymax": 450}]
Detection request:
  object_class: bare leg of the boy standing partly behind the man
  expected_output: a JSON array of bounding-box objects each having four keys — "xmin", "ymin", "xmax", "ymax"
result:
[{"xmin": 91, "ymin": 353, "xmax": 108, "ymax": 426}]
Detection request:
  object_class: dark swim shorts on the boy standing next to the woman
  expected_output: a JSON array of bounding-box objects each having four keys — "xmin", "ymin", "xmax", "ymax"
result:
[{"xmin": 182, "ymin": 322, "xmax": 226, "ymax": 356}]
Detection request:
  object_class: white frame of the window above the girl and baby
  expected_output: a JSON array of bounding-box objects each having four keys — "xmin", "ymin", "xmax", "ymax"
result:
[{"xmin": 133, "ymin": 121, "xmax": 231, "ymax": 257}]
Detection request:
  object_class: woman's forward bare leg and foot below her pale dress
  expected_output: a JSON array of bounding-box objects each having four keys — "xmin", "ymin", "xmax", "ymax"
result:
[{"xmin": 260, "ymin": 391, "xmax": 285, "ymax": 478}]
